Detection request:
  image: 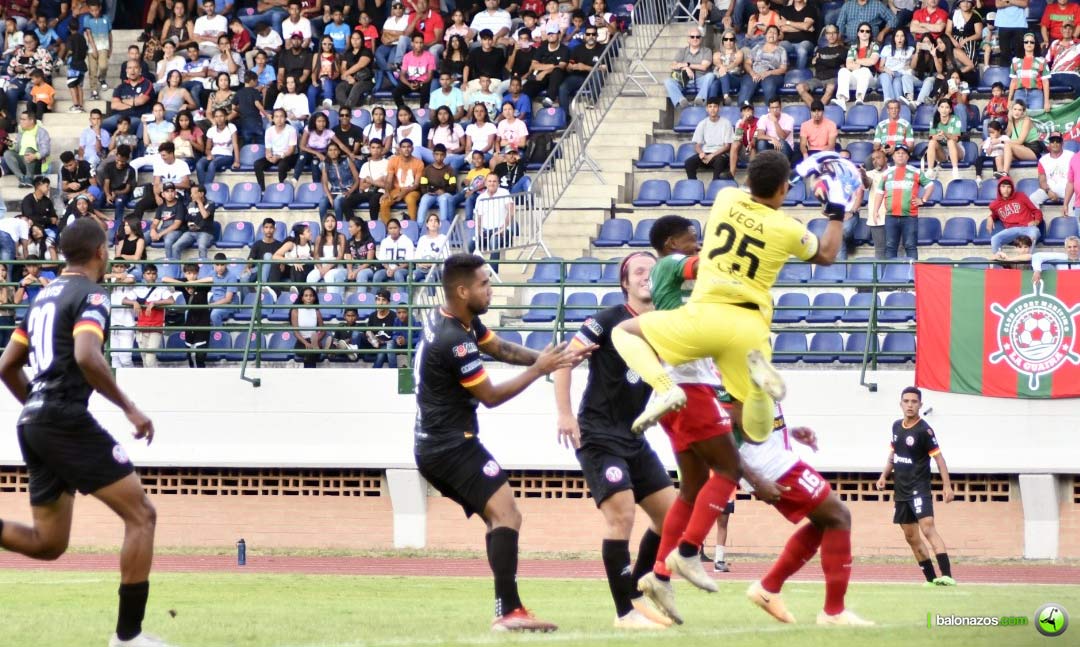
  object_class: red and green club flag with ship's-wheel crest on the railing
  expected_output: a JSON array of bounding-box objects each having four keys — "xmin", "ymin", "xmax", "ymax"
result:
[{"xmin": 915, "ymin": 264, "xmax": 1080, "ymax": 399}]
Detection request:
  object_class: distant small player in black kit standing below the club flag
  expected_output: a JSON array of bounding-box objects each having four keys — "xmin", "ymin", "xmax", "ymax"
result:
[{"xmin": 877, "ymin": 387, "xmax": 956, "ymax": 587}]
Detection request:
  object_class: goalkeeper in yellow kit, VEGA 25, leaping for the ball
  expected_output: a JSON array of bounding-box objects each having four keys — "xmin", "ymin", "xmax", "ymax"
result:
[{"xmin": 611, "ymin": 151, "xmax": 847, "ymax": 442}]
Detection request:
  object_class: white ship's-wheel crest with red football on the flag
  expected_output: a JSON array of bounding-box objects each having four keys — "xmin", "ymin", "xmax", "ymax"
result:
[{"xmin": 989, "ymin": 281, "xmax": 1080, "ymax": 390}]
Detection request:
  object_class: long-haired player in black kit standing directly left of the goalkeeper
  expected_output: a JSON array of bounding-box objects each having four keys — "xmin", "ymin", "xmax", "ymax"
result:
[{"xmin": 555, "ymin": 252, "xmax": 675, "ymax": 630}]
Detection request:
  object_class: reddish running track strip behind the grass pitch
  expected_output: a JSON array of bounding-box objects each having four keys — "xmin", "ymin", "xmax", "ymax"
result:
[{"xmin": 0, "ymin": 553, "xmax": 1080, "ymax": 584}]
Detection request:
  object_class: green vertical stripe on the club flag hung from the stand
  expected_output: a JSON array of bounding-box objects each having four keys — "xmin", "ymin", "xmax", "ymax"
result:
[{"xmin": 941, "ymin": 268, "xmax": 986, "ymax": 393}]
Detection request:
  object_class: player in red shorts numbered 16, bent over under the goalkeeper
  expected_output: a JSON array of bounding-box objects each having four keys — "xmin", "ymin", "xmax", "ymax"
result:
[{"xmin": 721, "ymin": 396, "xmax": 874, "ymax": 626}]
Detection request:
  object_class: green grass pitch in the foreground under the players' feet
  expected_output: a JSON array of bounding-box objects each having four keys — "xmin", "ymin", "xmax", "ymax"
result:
[{"xmin": 0, "ymin": 569, "xmax": 1080, "ymax": 647}]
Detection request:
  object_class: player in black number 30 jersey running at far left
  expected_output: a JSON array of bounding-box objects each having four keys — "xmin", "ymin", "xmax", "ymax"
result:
[{"xmin": 0, "ymin": 218, "xmax": 165, "ymax": 647}]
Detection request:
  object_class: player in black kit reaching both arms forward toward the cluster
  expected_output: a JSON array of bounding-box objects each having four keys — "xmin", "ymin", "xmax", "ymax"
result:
[{"xmin": 414, "ymin": 254, "xmax": 592, "ymax": 631}]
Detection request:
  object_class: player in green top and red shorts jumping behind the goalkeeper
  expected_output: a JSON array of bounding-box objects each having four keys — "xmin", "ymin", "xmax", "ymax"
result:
[{"xmin": 637, "ymin": 216, "xmax": 780, "ymax": 623}]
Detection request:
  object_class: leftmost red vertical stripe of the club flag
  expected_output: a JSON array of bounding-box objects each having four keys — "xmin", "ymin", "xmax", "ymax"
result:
[{"xmin": 915, "ymin": 264, "xmax": 953, "ymax": 391}]
